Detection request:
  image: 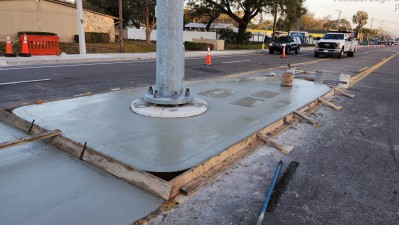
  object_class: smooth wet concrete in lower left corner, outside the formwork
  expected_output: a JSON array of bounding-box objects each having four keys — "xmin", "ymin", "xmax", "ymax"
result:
[{"xmin": 0, "ymin": 123, "xmax": 163, "ymax": 225}]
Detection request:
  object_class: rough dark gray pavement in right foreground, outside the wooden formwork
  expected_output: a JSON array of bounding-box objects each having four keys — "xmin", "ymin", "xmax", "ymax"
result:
[{"xmin": 148, "ymin": 51, "xmax": 399, "ymax": 225}]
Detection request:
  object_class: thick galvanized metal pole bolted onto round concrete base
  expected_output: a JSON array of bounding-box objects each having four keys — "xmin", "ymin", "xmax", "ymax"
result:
[{"xmin": 144, "ymin": 0, "xmax": 192, "ymax": 105}]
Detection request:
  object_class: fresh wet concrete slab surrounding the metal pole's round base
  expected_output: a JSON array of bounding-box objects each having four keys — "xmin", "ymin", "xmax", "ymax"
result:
[{"xmin": 14, "ymin": 77, "xmax": 329, "ymax": 172}]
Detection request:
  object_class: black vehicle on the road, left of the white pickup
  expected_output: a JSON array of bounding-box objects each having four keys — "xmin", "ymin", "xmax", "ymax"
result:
[{"xmin": 269, "ymin": 36, "xmax": 301, "ymax": 54}]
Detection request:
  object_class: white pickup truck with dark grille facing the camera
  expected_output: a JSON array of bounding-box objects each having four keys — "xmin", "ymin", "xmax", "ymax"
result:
[{"xmin": 314, "ymin": 32, "xmax": 358, "ymax": 59}]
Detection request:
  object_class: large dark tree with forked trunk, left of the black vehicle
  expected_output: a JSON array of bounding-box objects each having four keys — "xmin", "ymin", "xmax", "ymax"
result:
[{"xmin": 199, "ymin": 0, "xmax": 271, "ymax": 43}]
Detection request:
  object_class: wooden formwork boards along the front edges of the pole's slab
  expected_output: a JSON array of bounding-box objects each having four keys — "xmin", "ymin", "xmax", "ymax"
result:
[{"xmin": 0, "ymin": 89, "xmax": 354, "ymax": 200}]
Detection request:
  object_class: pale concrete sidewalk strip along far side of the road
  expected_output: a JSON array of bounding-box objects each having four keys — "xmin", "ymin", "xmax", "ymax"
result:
[{"xmin": 0, "ymin": 50, "xmax": 267, "ymax": 67}]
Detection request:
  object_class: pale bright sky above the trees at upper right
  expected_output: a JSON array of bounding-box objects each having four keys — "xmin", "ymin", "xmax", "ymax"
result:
[{"xmin": 305, "ymin": 0, "xmax": 399, "ymax": 34}]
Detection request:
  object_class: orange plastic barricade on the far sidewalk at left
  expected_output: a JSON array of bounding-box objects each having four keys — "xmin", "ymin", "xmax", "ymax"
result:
[{"xmin": 19, "ymin": 35, "xmax": 61, "ymax": 55}]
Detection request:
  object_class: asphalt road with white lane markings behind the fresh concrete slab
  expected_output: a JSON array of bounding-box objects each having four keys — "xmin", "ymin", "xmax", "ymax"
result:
[{"xmin": 0, "ymin": 47, "xmax": 397, "ymax": 108}]
